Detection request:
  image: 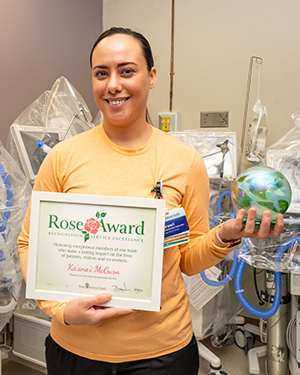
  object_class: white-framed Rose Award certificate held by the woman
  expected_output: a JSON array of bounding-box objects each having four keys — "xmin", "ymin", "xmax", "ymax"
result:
[{"xmin": 26, "ymin": 191, "xmax": 166, "ymax": 311}]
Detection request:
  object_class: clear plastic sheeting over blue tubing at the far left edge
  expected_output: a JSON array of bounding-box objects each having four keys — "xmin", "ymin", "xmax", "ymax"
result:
[{"xmin": 0, "ymin": 142, "xmax": 31, "ymax": 330}]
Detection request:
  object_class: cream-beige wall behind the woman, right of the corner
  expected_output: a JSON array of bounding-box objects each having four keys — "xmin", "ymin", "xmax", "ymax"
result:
[{"xmin": 103, "ymin": 0, "xmax": 300, "ymax": 150}]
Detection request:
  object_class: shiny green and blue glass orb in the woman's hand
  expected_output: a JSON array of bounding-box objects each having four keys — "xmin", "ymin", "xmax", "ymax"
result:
[{"xmin": 231, "ymin": 166, "xmax": 292, "ymax": 227}]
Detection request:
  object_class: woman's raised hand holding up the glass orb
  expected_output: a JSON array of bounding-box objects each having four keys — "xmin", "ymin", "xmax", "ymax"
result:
[{"xmin": 218, "ymin": 207, "xmax": 284, "ymax": 242}]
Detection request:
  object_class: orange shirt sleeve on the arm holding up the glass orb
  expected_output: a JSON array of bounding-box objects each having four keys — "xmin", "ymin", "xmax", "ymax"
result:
[{"xmin": 180, "ymin": 152, "xmax": 233, "ymax": 276}]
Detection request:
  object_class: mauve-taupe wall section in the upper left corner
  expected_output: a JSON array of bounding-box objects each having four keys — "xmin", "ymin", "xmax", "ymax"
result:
[{"xmin": 0, "ymin": 0, "xmax": 102, "ymax": 146}]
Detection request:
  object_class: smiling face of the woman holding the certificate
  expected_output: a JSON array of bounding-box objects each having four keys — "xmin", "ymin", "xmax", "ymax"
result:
[{"xmin": 92, "ymin": 34, "xmax": 156, "ymax": 126}]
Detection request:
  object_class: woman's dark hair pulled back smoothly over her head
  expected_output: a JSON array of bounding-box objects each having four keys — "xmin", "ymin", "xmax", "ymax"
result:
[{"xmin": 90, "ymin": 27, "xmax": 154, "ymax": 72}]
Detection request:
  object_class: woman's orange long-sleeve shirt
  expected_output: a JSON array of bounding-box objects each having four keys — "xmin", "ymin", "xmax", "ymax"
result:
[{"xmin": 18, "ymin": 125, "xmax": 232, "ymax": 362}]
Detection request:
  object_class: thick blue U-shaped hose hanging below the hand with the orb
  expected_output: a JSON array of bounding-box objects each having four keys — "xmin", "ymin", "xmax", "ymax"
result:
[{"xmin": 234, "ymin": 236, "xmax": 300, "ymax": 319}]
